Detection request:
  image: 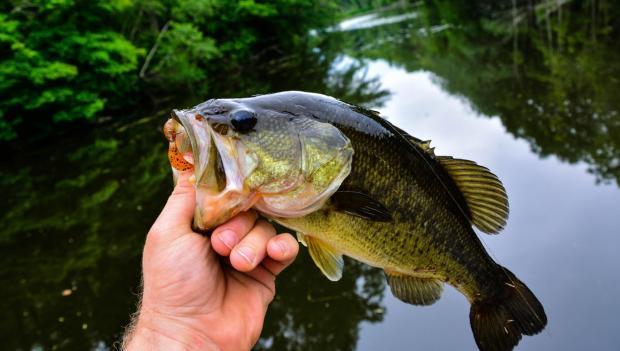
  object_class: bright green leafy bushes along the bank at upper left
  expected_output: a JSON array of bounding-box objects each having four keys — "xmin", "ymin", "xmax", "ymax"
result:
[{"xmin": 0, "ymin": 0, "xmax": 337, "ymax": 141}]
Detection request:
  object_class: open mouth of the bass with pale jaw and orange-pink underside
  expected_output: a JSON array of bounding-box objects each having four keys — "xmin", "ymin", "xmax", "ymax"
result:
[{"xmin": 172, "ymin": 109, "xmax": 258, "ymax": 230}]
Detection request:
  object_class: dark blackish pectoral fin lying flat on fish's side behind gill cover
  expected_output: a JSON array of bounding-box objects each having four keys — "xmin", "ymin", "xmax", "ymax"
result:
[{"xmin": 331, "ymin": 190, "xmax": 392, "ymax": 222}]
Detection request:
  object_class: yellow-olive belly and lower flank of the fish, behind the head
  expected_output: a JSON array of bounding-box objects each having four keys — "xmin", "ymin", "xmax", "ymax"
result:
[{"xmin": 276, "ymin": 211, "xmax": 490, "ymax": 298}]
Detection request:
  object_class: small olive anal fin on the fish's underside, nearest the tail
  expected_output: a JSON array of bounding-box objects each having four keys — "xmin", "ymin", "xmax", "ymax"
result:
[{"xmin": 385, "ymin": 271, "xmax": 443, "ymax": 305}]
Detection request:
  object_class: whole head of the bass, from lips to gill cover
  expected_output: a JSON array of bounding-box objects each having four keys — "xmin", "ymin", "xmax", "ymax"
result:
[{"xmin": 168, "ymin": 98, "xmax": 353, "ymax": 230}]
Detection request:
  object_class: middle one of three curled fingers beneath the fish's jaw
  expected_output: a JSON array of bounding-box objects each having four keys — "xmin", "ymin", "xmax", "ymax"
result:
[{"xmin": 230, "ymin": 219, "xmax": 276, "ymax": 272}]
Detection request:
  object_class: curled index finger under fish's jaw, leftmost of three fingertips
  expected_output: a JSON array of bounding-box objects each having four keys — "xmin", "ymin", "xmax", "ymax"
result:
[{"xmin": 211, "ymin": 211, "xmax": 256, "ymax": 256}]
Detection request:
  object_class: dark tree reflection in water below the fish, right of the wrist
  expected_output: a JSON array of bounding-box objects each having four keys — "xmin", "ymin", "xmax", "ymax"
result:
[{"xmin": 255, "ymin": 254, "xmax": 385, "ymax": 351}]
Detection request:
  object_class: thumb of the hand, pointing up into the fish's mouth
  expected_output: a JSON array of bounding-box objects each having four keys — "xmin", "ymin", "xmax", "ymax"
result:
[{"xmin": 149, "ymin": 172, "xmax": 196, "ymax": 240}]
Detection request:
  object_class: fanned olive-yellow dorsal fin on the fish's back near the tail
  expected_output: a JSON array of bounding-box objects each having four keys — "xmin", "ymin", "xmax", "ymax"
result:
[{"xmin": 437, "ymin": 156, "xmax": 508, "ymax": 234}]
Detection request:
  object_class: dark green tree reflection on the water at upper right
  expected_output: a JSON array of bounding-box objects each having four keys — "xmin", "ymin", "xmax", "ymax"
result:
[{"xmin": 336, "ymin": 1, "xmax": 620, "ymax": 183}]
